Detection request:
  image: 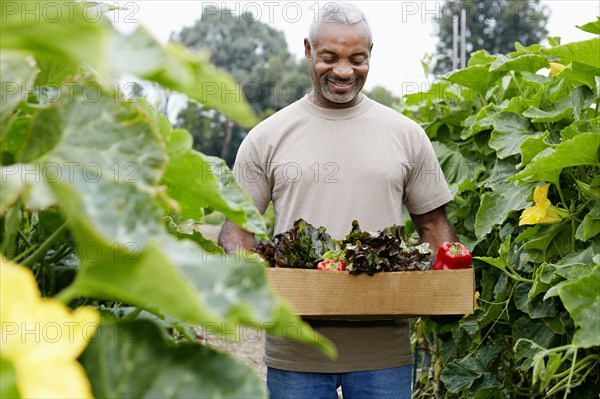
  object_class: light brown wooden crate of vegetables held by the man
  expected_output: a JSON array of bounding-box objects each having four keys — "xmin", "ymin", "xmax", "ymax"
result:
[{"xmin": 268, "ymin": 268, "xmax": 475, "ymax": 319}]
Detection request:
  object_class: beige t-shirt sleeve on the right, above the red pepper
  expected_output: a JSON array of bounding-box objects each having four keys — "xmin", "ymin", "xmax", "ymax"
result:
[{"xmin": 403, "ymin": 127, "xmax": 453, "ymax": 215}]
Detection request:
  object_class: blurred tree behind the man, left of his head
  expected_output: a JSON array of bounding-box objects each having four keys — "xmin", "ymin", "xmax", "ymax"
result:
[{"xmin": 172, "ymin": 9, "xmax": 312, "ymax": 165}]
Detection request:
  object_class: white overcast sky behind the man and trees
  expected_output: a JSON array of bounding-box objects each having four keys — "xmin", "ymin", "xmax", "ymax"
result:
[{"xmin": 110, "ymin": 0, "xmax": 600, "ymax": 96}]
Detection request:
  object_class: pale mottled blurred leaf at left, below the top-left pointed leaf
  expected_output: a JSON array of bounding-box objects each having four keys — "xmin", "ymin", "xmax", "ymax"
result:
[{"xmin": 22, "ymin": 85, "xmax": 166, "ymax": 188}]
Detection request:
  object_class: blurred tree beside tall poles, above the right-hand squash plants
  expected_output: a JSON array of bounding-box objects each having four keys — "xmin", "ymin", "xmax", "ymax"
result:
[{"xmin": 434, "ymin": 0, "xmax": 550, "ymax": 74}]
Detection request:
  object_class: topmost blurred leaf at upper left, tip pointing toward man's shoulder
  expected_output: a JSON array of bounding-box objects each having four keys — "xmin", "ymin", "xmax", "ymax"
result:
[{"xmin": 0, "ymin": 1, "xmax": 257, "ymax": 127}]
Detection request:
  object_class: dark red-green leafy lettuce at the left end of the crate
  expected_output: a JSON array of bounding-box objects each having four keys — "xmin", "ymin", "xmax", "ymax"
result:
[{"xmin": 256, "ymin": 219, "xmax": 338, "ymax": 269}]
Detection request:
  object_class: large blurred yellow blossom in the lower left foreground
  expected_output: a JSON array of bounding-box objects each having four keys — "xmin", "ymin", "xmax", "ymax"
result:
[{"xmin": 0, "ymin": 260, "xmax": 100, "ymax": 399}]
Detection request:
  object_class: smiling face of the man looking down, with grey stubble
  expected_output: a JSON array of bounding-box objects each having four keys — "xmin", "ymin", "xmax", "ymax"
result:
[{"xmin": 304, "ymin": 22, "xmax": 372, "ymax": 108}]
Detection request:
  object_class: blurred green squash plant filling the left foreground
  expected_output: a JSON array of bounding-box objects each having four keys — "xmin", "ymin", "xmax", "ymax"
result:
[{"xmin": 0, "ymin": 1, "xmax": 334, "ymax": 397}]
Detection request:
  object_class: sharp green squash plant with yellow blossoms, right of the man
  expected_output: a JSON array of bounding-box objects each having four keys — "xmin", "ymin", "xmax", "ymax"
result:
[{"xmin": 399, "ymin": 20, "xmax": 600, "ymax": 398}]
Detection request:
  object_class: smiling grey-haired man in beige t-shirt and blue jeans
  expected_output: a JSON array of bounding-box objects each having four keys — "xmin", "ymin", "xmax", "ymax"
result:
[{"xmin": 219, "ymin": 3, "xmax": 456, "ymax": 399}]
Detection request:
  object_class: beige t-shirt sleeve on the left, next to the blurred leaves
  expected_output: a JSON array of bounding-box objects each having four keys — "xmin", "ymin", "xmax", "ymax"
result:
[{"xmin": 233, "ymin": 138, "xmax": 271, "ymax": 214}]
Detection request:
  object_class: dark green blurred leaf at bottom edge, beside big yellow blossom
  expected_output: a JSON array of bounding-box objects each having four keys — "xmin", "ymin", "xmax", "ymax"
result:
[{"xmin": 80, "ymin": 320, "xmax": 267, "ymax": 399}]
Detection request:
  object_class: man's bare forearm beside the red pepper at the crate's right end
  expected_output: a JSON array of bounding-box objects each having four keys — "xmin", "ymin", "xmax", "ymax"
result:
[{"xmin": 410, "ymin": 206, "xmax": 458, "ymax": 255}]
